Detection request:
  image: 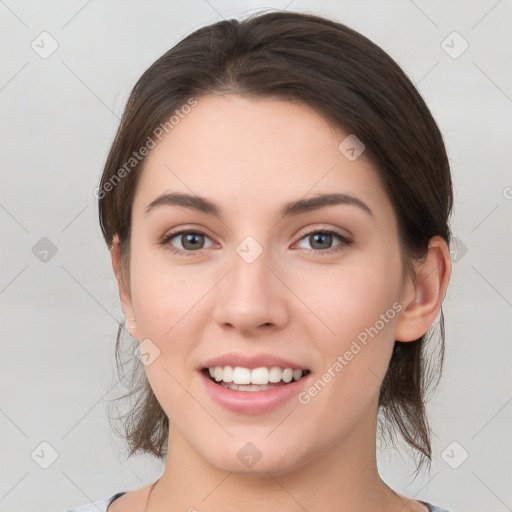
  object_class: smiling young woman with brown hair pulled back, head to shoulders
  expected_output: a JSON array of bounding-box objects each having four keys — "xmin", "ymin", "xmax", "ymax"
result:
[{"xmin": 67, "ymin": 12, "xmax": 452, "ymax": 512}]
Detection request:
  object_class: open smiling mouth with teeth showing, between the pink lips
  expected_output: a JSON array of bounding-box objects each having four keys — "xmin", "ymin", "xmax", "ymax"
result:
[{"xmin": 201, "ymin": 366, "xmax": 310, "ymax": 392}]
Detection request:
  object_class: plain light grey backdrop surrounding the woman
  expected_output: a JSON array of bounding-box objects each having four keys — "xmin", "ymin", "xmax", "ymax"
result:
[{"xmin": 0, "ymin": 0, "xmax": 512, "ymax": 512}]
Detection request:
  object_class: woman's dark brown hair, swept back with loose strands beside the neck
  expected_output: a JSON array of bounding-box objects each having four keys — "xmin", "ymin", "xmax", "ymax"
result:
[{"xmin": 97, "ymin": 12, "xmax": 453, "ymax": 469}]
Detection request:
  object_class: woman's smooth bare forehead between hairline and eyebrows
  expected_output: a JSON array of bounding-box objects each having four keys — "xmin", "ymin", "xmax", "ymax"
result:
[{"xmin": 134, "ymin": 94, "xmax": 390, "ymax": 224}]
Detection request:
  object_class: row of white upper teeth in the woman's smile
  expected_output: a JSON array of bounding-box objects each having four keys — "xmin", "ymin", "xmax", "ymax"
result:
[{"xmin": 208, "ymin": 366, "xmax": 304, "ymax": 384}]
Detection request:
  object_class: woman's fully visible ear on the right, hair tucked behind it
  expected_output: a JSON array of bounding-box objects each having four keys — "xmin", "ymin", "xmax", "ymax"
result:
[{"xmin": 395, "ymin": 236, "xmax": 452, "ymax": 341}]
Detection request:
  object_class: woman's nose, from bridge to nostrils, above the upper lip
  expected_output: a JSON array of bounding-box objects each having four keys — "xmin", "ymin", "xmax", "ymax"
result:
[{"xmin": 213, "ymin": 241, "xmax": 290, "ymax": 336}]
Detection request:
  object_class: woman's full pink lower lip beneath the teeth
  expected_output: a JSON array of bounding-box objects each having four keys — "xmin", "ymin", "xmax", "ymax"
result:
[{"xmin": 199, "ymin": 371, "xmax": 311, "ymax": 414}]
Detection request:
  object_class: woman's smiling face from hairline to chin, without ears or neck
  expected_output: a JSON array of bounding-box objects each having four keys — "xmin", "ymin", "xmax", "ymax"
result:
[{"xmin": 123, "ymin": 95, "xmax": 412, "ymax": 474}]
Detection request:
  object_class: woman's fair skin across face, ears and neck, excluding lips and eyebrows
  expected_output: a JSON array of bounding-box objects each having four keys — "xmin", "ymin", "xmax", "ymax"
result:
[{"xmin": 109, "ymin": 94, "xmax": 451, "ymax": 512}]
